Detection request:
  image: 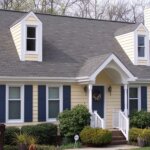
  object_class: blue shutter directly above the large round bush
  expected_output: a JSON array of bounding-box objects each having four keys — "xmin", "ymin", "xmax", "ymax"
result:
[{"xmin": 63, "ymin": 85, "xmax": 71, "ymax": 110}]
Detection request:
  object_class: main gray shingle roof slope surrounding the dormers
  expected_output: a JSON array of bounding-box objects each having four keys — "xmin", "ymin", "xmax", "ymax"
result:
[{"xmin": 0, "ymin": 10, "xmax": 150, "ymax": 78}]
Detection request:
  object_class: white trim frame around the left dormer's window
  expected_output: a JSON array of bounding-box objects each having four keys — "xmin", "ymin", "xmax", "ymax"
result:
[{"xmin": 25, "ymin": 25, "xmax": 39, "ymax": 55}]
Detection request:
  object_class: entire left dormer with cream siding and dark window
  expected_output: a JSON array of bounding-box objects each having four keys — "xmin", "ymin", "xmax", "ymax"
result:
[{"xmin": 10, "ymin": 12, "xmax": 42, "ymax": 61}]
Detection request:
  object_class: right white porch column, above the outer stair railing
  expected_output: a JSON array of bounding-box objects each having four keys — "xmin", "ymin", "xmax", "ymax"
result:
[{"xmin": 124, "ymin": 84, "xmax": 128, "ymax": 116}]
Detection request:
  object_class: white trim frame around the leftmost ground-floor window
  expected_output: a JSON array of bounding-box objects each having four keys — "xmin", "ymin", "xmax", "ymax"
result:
[{"xmin": 6, "ymin": 84, "xmax": 24, "ymax": 123}]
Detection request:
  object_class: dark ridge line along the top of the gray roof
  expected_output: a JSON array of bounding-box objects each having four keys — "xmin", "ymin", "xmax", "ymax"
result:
[{"xmin": 0, "ymin": 9, "xmax": 135, "ymax": 24}]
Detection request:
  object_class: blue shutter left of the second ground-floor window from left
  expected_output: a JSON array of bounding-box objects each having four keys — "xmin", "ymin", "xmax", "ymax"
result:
[{"xmin": 38, "ymin": 85, "xmax": 46, "ymax": 121}]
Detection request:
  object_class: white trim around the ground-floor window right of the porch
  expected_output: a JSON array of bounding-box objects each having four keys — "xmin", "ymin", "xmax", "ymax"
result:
[{"xmin": 128, "ymin": 85, "xmax": 141, "ymax": 114}]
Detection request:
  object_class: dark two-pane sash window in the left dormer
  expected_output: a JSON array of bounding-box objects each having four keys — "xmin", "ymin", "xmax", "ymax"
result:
[{"xmin": 26, "ymin": 26, "xmax": 36, "ymax": 51}]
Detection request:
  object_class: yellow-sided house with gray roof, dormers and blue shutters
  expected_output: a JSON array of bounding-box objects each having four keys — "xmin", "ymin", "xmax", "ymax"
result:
[{"xmin": 0, "ymin": 9, "xmax": 150, "ymax": 140}]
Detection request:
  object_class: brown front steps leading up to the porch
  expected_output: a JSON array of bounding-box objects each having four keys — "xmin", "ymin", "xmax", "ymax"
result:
[{"xmin": 111, "ymin": 130, "xmax": 127, "ymax": 145}]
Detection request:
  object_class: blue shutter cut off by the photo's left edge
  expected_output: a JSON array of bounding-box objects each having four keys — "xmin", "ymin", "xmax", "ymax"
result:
[{"xmin": 0, "ymin": 85, "xmax": 6, "ymax": 123}]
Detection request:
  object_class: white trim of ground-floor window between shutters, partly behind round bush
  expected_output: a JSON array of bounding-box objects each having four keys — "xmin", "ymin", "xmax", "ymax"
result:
[{"xmin": 46, "ymin": 85, "xmax": 63, "ymax": 122}]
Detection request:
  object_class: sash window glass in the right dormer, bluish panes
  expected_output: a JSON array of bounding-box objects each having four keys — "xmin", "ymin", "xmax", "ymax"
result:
[{"xmin": 138, "ymin": 35, "xmax": 145, "ymax": 58}]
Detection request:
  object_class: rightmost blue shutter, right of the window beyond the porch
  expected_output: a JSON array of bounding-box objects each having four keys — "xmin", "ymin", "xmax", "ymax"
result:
[{"xmin": 141, "ymin": 86, "xmax": 147, "ymax": 111}]
